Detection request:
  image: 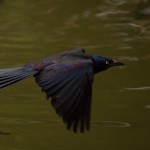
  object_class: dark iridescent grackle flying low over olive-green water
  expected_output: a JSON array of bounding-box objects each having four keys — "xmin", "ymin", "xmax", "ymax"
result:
[{"xmin": 0, "ymin": 48, "xmax": 124, "ymax": 133}]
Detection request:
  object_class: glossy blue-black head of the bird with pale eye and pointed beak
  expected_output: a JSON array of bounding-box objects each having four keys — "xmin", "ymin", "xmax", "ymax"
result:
[{"xmin": 92, "ymin": 55, "xmax": 124, "ymax": 73}]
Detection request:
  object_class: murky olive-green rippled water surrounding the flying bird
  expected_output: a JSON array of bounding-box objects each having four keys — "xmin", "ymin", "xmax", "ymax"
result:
[{"xmin": 0, "ymin": 0, "xmax": 150, "ymax": 150}]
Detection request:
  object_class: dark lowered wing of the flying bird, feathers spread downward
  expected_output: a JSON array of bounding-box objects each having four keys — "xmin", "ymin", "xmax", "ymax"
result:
[{"xmin": 35, "ymin": 60, "xmax": 93, "ymax": 132}]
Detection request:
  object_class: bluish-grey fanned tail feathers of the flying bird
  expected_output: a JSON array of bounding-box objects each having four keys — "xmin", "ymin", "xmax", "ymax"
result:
[{"xmin": 0, "ymin": 67, "xmax": 37, "ymax": 89}]
